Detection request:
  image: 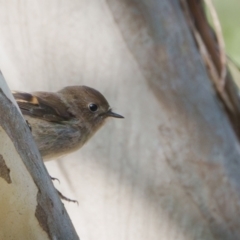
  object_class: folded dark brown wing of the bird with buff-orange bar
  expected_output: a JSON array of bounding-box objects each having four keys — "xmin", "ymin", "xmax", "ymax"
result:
[{"xmin": 12, "ymin": 92, "xmax": 74, "ymax": 122}]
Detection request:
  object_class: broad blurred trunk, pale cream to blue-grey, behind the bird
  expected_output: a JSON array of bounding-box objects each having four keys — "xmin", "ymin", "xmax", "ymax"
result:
[{"xmin": 0, "ymin": 0, "xmax": 240, "ymax": 240}]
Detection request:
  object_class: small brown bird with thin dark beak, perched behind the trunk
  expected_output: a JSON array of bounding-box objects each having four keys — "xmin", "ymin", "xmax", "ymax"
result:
[{"xmin": 13, "ymin": 86, "xmax": 123, "ymax": 161}]
